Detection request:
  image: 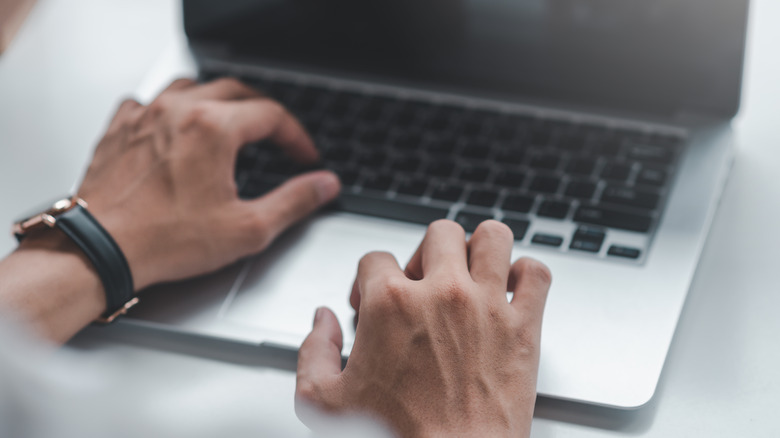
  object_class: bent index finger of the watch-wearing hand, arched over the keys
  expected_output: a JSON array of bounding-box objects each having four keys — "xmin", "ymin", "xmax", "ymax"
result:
[{"xmin": 225, "ymin": 98, "xmax": 319, "ymax": 163}]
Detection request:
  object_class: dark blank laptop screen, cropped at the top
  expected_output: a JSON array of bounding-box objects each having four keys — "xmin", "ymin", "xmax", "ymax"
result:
[{"xmin": 184, "ymin": 0, "xmax": 748, "ymax": 116}]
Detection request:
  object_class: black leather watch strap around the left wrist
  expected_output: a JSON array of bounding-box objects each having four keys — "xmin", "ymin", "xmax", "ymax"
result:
[{"xmin": 55, "ymin": 205, "xmax": 137, "ymax": 322}]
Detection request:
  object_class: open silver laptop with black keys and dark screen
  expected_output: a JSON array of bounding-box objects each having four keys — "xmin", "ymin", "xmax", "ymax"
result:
[{"xmin": 121, "ymin": 0, "xmax": 748, "ymax": 409}]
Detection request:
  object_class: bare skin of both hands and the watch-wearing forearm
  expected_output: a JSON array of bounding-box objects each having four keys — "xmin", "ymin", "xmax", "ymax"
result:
[{"xmin": 0, "ymin": 79, "xmax": 550, "ymax": 436}]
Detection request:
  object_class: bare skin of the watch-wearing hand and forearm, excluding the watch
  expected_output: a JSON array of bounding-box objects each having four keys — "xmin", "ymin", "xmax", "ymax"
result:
[{"xmin": 0, "ymin": 79, "xmax": 340, "ymax": 343}]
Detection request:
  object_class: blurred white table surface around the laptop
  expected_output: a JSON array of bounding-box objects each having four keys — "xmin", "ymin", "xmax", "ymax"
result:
[{"xmin": 0, "ymin": 0, "xmax": 780, "ymax": 437}]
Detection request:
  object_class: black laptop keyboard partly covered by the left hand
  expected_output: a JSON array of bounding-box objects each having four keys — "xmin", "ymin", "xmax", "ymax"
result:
[{"xmin": 224, "ymin": 73, "xmax": 683, "ymax": 260}]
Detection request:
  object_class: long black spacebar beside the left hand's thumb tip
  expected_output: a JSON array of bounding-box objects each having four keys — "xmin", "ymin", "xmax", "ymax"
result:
[{"xmin": 336, "ymin": 193, "xmax": 449, "ymax": 225}]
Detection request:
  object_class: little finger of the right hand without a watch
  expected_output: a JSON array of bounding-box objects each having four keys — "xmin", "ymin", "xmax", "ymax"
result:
[{"xmin": 507, "ymin": 257, "xmax": 552, "ymax": 336}]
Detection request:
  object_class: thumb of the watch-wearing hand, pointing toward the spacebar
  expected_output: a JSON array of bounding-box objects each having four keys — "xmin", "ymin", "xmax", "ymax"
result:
[{"xmin": 245, "ymin": 170, "xmax": 341, "ymax": 250}]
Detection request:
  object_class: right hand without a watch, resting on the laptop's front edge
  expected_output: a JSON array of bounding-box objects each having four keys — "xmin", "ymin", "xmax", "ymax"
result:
[{"xmin": 296, "ymin": 220, "xmax": 551, "ymax": 437}]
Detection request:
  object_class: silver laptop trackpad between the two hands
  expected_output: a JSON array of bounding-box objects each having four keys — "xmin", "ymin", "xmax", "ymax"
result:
[{"xmin": 223, "ymin": 213, "xmax": 425, "ymax": 344}]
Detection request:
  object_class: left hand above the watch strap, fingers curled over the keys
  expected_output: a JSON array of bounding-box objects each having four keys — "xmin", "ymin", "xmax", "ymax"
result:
[{"xmin": 78, "ymin": 79, "xmax": 340, "ymax": 289}]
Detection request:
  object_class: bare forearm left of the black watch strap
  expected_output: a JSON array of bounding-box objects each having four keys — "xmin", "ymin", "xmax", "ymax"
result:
[{"xmin": 0, "ymin": 230, "xmax": 106, "ymax": 343}]
